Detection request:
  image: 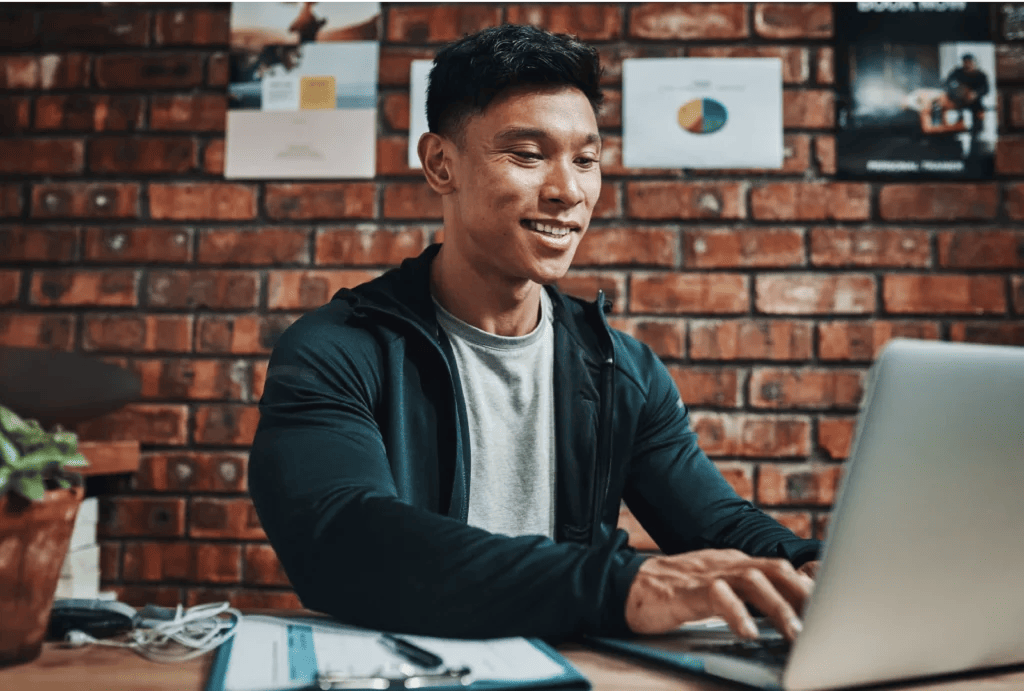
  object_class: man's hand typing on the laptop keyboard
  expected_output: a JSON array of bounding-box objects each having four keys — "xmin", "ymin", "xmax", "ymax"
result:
[{"xmin": 626, "ymin": 550, "xmax": 814, "ymax": 640}]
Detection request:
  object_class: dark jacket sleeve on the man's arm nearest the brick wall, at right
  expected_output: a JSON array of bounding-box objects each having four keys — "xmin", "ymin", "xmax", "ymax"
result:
[{"xmin": 624, "ymin": 347, "xmax": 821, "ymax": 566}]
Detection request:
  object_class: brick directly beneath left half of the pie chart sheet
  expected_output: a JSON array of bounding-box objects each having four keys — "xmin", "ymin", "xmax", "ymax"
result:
[{"xmin": 626, "ymin": 181, "xmax": 746, "ymax": 220}]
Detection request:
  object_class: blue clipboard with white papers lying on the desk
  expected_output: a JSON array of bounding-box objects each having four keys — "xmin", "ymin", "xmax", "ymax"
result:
[{"xmin": 204, "ymin": 615, "xmax": 591, "ymax": 691}]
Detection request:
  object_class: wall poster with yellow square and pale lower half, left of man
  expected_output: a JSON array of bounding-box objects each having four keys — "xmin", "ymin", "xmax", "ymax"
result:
[{"xmin": 224, "ymin": 1, "xmax": 380, "ymax": 179}]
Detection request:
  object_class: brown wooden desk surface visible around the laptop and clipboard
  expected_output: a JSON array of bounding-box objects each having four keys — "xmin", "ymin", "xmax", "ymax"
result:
[{"xmin": 6, "ymin": 643, "xmax": 1024, "ymax": 691}]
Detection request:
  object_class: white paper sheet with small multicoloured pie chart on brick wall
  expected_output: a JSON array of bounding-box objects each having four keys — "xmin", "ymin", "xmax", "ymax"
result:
[{"xmin": 623, "ymin": 57, "xmax": 782, "ymax": 169}]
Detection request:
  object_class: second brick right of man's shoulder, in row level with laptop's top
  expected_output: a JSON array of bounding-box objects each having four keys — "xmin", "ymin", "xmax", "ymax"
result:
[{"xmin": 690, "ymin": 319, "xmax": 813, "ymax": 360}]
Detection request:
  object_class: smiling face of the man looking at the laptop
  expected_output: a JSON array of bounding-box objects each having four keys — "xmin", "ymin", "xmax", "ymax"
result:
[{"xmin": 444, "ymin": 87, "xmax": 601, "ymax": 289}]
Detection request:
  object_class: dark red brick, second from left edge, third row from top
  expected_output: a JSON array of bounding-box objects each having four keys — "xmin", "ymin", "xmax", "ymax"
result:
[{"xmin": 35, "ymin": 94, "xmax": 145, "ymax": 132}]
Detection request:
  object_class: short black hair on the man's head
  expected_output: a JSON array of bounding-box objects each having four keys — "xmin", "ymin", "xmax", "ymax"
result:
[{"xmin": 427, "ymin": 24, "xmax": 604, "ymax": 137}]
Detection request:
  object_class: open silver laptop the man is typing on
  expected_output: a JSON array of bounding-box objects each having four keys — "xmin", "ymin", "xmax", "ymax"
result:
[{"xmin": 599, "ymin": 339, "xmax": 1024, "ymax": 691}]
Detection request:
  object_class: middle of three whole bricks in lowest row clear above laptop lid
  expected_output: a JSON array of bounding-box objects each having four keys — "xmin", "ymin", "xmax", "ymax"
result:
[{"xmin": 755, "ymin": 273, "xmax": 876, "ymax": 314}]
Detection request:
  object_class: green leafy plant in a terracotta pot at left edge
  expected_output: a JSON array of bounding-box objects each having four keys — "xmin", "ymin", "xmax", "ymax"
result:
[{"xmin": 0, "ymin": 405, "xmax": 88, "ymax": 665}]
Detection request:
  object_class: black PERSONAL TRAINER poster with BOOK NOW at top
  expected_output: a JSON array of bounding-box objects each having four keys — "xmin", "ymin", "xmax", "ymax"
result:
[{"xmin": 835, "ymin": 0, "xmax": 997, "ymax": 179}]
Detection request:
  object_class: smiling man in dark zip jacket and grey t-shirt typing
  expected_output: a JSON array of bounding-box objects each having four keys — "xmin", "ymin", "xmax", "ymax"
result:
[{"xmin": 249, "ymin": 26, "xmax": 819, "ymax": 638}]
